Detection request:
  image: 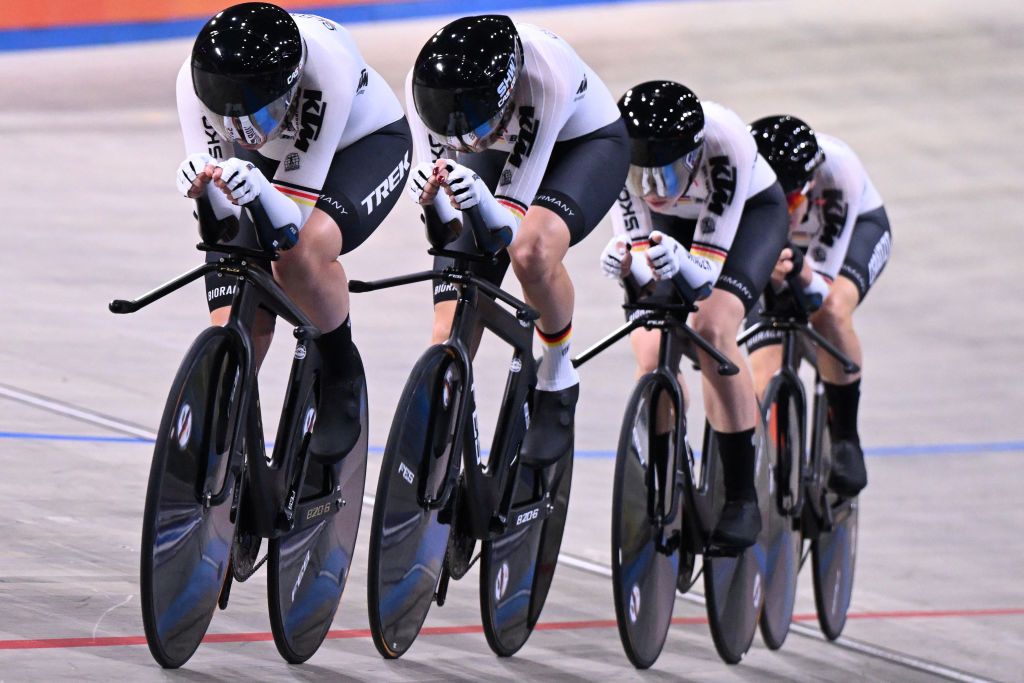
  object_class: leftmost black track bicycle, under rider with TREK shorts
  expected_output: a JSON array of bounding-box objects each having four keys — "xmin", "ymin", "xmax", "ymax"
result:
[{"xmin": 110, "ymin": 199, "xmax": 368, "ymax": 669}]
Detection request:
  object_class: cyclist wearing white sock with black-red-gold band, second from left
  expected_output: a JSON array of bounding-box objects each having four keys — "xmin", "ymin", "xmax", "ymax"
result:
[{"xmin": 406, "ymin": 15, "xmax": 629, "ymax": 466}]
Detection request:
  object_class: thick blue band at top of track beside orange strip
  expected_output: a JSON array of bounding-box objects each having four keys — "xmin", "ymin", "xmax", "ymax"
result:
[{"xmin": 0, "ymin": 0, "xmax": 667, "ymax": 52}]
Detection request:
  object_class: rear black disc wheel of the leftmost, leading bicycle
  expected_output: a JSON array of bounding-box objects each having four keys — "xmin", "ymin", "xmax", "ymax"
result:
[{"xmin": 267, "ymin": 368, "xmax": 369, "ymax": 664}]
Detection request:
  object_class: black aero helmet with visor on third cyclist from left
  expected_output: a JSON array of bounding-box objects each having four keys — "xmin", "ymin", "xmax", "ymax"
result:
[{"xmin": 618, "ymin": 81, "xmax": 705, "ymax": 197}]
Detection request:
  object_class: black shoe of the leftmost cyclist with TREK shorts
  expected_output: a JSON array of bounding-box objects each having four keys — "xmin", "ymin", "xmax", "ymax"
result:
[{"xmin": 309, "ymin": 372, "xmax": 366, "ymax": 465}]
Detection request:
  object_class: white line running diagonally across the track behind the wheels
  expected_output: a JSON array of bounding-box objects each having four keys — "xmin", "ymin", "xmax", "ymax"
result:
[{"xmin": 0, "ymin": 384, "xmax": 994, "ymax": 683}]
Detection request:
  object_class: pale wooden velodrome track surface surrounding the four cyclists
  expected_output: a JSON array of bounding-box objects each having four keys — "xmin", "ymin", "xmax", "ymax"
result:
[{"xmin": 0, "ymin": 0, "xmax": 1024, "ymax": 681}]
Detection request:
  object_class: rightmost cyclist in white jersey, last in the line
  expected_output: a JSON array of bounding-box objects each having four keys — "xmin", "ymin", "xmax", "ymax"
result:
[{"xmin": 748, "ymin": 116, "xmax": 892, "ymax": 496}]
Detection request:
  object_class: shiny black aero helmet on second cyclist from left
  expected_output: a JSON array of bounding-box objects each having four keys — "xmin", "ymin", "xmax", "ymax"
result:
[{"xmin": 413, "ymin": 14, "xmax": 523, "ymax": 152}]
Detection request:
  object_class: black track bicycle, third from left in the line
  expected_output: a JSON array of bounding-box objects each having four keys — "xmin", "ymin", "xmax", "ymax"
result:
[{"xmin": 573, "ymin": 275, "xmax": 768, "ymax": 669}]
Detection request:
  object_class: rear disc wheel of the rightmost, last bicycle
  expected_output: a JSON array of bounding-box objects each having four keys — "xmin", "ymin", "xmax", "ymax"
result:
[{"xmin": 811, "ymin": 411, "xmax": 859, "ymax": 640}]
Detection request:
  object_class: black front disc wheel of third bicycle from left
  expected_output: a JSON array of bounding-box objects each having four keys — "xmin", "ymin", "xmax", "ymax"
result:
[{"xmin": 611, "ymin": 375, "xmax": 683, "ymax": 669}]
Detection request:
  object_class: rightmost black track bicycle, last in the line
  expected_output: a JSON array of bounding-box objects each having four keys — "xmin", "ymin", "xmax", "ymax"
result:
[{"xmin": 738, "ymin": 259, "xmax": 860, "ymax": 649}]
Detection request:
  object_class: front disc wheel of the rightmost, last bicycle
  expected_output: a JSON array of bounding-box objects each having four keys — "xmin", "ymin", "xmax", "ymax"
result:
[{"xmin": 761, "ymin": 376, "xmax": 804, "ymax": 650}]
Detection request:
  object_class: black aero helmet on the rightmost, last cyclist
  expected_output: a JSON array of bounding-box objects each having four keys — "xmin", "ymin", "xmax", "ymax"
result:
[{"xmin": 751, "ymin": 115, "xmax": 824, "ymax": 195}]
